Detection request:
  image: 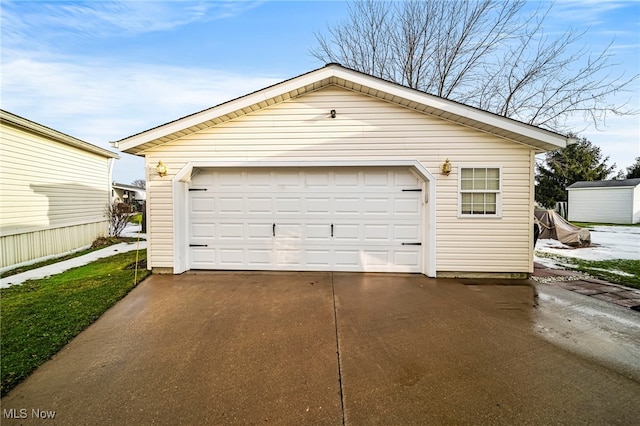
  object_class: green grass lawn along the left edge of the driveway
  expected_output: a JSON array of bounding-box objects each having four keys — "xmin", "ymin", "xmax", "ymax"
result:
[{"xmin": 0, "ymin": 250, "xmax": 150, "ymax": 395}]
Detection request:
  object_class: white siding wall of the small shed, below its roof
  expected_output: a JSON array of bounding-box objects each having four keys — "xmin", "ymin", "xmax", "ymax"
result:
[{"xmin": 568, "ymin": 187, "xmax": 638, "ymax": 224}]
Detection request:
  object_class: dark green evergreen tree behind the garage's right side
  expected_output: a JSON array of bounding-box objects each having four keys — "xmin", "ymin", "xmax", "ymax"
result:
[{"xmin": 536, "ymin": 138, "xmax": 616, "ymax": 208}]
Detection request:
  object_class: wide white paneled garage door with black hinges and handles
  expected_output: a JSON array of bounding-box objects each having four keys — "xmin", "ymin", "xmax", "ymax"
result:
[{"xmin": 189, "ymin": 167, "xmax": 424, "ymax": 272}]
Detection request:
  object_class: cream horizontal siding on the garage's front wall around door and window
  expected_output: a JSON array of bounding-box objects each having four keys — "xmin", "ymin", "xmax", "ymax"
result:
[{"xmin": 146, "ymin": 87, "xmax": 533, "ymax": 273}]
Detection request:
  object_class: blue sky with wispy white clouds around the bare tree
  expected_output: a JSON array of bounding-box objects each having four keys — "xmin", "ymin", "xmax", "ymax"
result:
[{"xmin": 0, "ymin": 0, "xmax": 640, "ymax": 183}]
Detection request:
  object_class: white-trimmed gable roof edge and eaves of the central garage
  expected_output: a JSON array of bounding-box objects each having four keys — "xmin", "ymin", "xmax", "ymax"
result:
[{"xmin": 114, "ymin": 63, "xmax": 571, "ymax": 154}]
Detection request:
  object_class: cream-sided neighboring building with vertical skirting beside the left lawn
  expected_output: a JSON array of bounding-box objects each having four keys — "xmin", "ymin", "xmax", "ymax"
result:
[{"xmin": 0, "ymin": 110, "xmax": 120, "ymax": 269}]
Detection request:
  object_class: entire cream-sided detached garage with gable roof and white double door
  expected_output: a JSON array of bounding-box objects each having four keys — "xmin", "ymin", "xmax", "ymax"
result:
[{"xmin": 116, "ymin": 64, "xmax": 569, "ymax": 277}]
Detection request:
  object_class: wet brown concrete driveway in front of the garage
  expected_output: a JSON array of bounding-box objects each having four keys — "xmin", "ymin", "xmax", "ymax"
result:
[{"xmin": 2, "ymin": 273, "xmax": 640, "ymax": 425}]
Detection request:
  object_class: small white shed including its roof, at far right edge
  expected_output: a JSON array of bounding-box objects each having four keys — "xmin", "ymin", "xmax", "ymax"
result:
[{"xmin": 567, "ymin": 178, "xmax": 640, "ymax": 224}]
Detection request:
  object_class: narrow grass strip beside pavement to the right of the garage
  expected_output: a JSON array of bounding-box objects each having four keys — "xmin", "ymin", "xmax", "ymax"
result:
[{"xmin": 536, "ymin": 251, "xmax": 640, "ymax": 289}]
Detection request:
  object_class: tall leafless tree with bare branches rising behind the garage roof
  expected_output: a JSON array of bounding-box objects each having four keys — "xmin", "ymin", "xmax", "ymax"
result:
[{"xmin": 311, "ymin": 0, "xmax": 638, "ymax": 131}]
